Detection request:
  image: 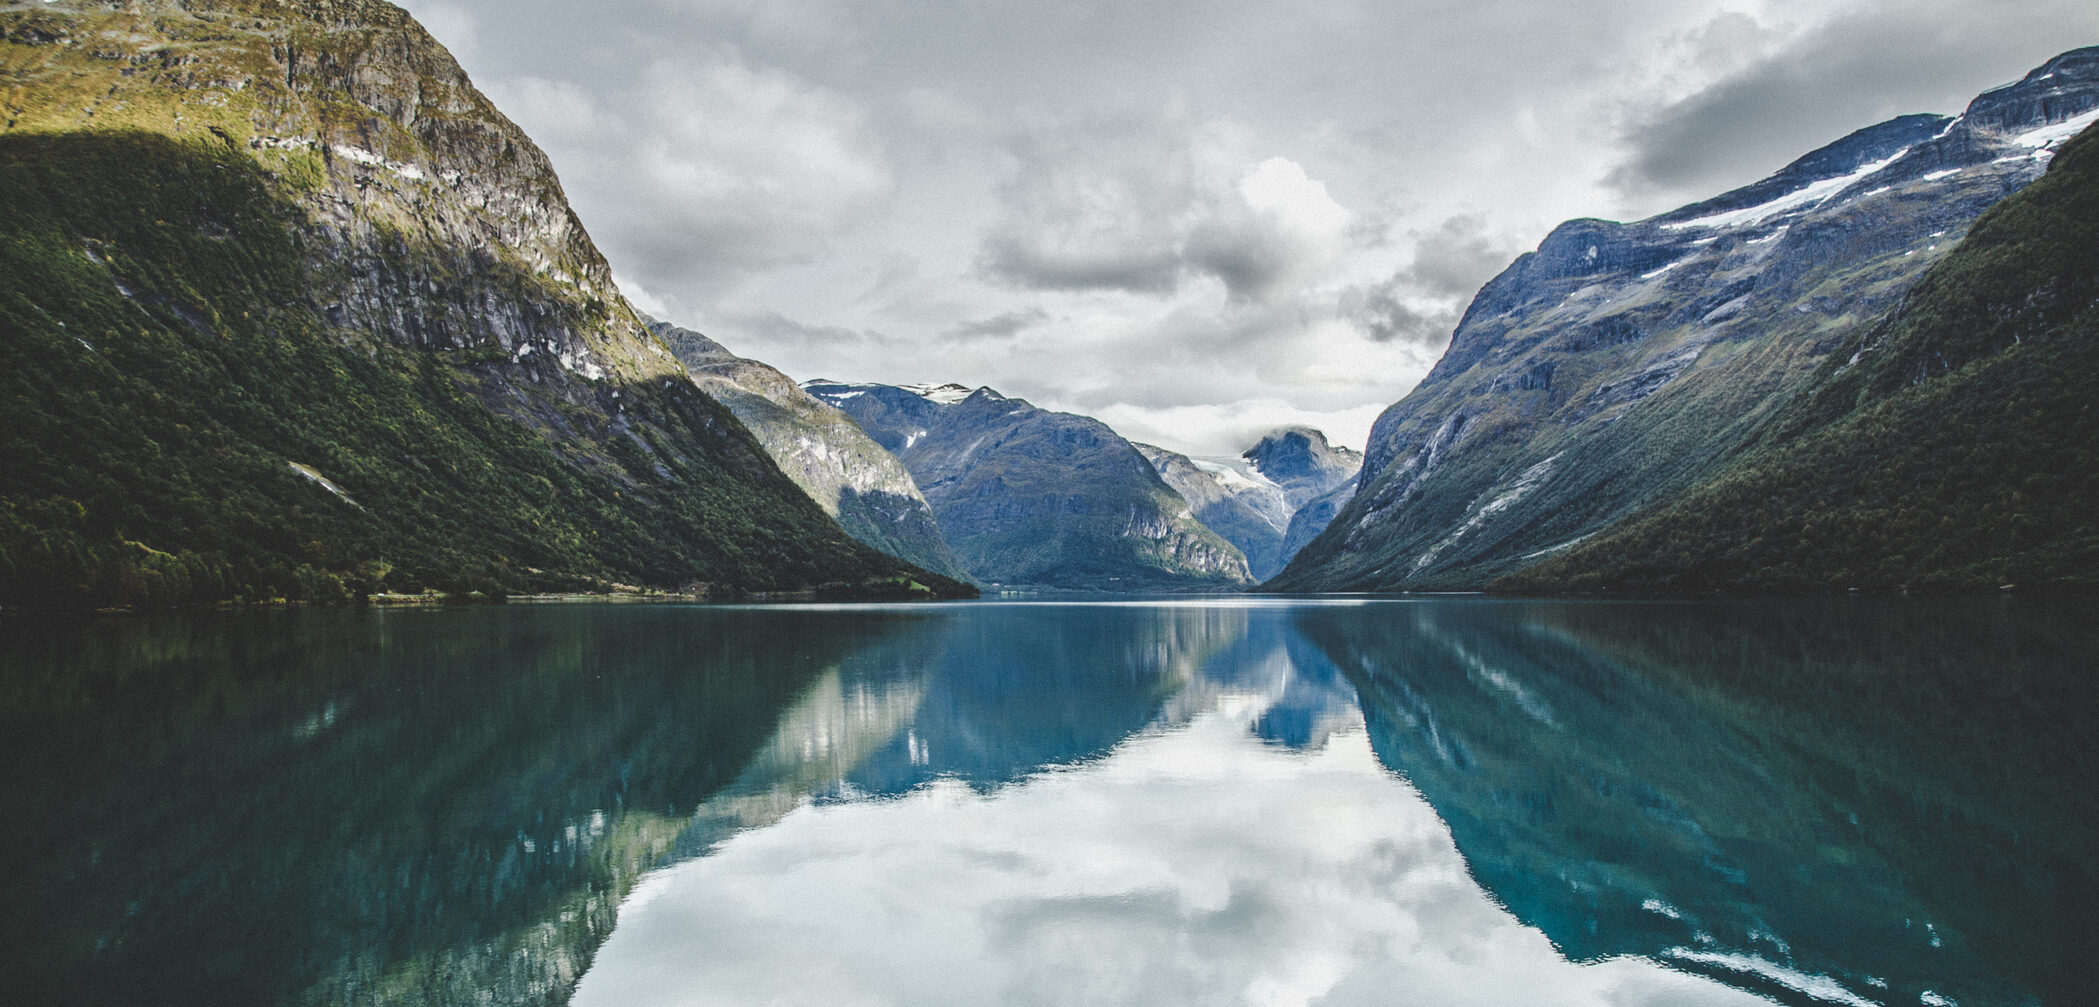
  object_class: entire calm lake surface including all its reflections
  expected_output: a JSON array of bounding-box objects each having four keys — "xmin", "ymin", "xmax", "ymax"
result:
[{"xmin": 0, "ymin": 598, "xmax": 2099, "ymax": 1007}]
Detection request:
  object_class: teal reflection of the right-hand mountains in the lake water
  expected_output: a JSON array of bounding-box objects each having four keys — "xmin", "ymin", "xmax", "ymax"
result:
[{"xmin": 1297, "ymin": 602, "xmax": 2099, "ymax": 1003}]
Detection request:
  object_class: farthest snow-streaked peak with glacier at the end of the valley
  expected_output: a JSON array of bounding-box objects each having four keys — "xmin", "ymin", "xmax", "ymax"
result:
[{"xmin": 1136, "ymin": 428, "xmax": 1362, "ymax": 581}]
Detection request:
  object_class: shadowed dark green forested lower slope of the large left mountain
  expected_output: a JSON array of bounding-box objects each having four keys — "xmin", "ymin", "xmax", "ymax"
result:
[{"xmin": 0, "ymin": 132, "xmax": 961, "ymax": 608}]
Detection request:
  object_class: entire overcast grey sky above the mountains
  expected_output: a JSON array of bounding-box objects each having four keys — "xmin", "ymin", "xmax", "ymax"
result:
[{"xmin": 390, "ymin": 0, "xmax": 2099, "ymax": 455}]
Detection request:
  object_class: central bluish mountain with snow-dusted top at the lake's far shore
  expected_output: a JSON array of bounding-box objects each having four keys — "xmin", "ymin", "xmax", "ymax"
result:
[{"xmin": 802, "ymin": 380, "xmax": 1249, "ymax": 587}]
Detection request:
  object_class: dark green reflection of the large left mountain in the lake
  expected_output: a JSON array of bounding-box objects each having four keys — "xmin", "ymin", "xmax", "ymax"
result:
[{"xmin": 0, "ymin": 606, "xmax": 911, "ymax": 1005}]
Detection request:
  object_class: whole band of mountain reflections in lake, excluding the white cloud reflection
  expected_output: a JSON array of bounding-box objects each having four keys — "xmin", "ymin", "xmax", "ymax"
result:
[{"xmin": 12, "ymin": 600, "xmax": 2099, "ymax": 1005}]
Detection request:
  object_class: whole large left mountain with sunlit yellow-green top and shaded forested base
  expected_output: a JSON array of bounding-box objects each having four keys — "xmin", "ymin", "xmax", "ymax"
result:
[{"xmin": 0, "ymin": 0, "xmax": 968, "ymax": 608}]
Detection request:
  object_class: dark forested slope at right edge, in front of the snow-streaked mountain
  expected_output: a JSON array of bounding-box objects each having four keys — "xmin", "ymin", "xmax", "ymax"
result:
[{"xmin": 1503, "ymin": 120, "xmax": 2099, "ymax": 592}]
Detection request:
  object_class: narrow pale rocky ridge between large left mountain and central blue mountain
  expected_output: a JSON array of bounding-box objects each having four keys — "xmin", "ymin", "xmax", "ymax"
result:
[{"xmin": 649, "ymin": 321, "xmax": 963, "ymax": 579}]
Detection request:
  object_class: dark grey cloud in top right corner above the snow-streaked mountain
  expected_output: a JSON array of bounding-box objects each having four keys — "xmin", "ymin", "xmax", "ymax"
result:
[{"xmin": 1608, "ymin": 0, "xmax": 2099, "ymax": 197}]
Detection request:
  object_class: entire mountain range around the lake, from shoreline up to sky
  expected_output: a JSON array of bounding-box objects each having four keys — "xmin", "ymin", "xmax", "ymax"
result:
[{"xmin": 0, "ymin": 0, "xmax": 2099, "ymax": 610}]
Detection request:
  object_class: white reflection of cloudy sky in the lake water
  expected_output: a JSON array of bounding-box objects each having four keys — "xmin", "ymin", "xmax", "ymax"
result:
[{"xmin": 575, "ymin": 703, "xmax": 1765, "ymax": 1007}]
